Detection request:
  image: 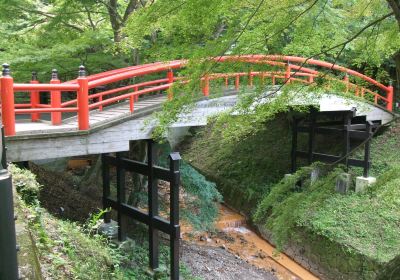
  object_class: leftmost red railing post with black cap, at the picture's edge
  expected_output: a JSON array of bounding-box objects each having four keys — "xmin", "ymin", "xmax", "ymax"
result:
[{"xmin": 0, "ymin": 63, "xmax": 15, "ymax": 136}]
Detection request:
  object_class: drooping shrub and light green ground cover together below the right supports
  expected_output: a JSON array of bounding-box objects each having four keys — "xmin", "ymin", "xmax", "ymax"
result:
[{"xmin": 254, "ymin": 160, "xmax": 400, "ymax": 262}]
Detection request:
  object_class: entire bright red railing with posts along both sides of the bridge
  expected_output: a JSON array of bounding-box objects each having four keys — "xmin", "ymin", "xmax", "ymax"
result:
[{"xmin": 0, "ymin": 55, "xmax": 393, "ymax": 136}]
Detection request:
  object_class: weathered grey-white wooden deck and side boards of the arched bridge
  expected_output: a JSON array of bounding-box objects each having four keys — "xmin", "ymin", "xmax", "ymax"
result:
[{"xmin": 6, "ymin": 87, "xmax": 393, "ymax": 162}]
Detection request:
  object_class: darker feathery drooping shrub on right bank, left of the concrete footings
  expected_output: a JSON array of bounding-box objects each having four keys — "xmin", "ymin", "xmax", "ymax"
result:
[{"xmin": 254, "ymin": 163, "xmax": 343, "ymax": 249}]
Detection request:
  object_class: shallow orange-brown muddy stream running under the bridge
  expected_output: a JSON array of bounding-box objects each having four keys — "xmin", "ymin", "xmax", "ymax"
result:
[{"xmin": 182, "ymin": 205, "xmax": 319, "ymax": 280}]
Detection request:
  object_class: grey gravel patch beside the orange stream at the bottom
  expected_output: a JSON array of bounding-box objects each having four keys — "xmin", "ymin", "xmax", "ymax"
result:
[{"xmin": 181, "ymin": 242, "xmax": 278, "ymax": 280}]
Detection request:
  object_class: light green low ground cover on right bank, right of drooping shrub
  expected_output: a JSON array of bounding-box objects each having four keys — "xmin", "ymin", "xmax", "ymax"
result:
[{"xmin": 299, "ymin": 165, "xmax": 400, "ymax": 262}]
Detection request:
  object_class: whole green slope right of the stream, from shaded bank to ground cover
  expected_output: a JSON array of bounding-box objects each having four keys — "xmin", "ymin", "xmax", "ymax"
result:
[{"xmin": 184, "ymin": 115, "xmax": 400, "ymax": 279}]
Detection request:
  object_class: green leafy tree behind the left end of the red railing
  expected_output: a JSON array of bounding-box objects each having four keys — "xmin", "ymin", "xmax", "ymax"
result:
[{"xmin": 0, "ymin": 0, "xmax": 145, "ymax": 81}]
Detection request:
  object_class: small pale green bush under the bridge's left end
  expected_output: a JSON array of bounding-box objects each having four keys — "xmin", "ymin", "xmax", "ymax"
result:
[{"xmin": 9, "ymin": 164, "xmax": 42, "ymax": 205}]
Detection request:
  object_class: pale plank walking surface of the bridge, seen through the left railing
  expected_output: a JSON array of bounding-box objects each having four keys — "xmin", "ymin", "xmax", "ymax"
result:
[{"xmin": 14, "ymin": 95, "xmax": 167, "ymax": 137}]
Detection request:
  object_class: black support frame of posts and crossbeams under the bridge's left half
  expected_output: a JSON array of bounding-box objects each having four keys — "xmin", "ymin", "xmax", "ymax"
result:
[{"xmin": 102, "ymin": 140, "xmax": 181, "ymax": 280}]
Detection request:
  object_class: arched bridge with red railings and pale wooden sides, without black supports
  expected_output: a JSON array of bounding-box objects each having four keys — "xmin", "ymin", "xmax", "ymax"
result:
[{"xmin": 0, "ymin": 55, "xmax": 393, "ymax": 161}]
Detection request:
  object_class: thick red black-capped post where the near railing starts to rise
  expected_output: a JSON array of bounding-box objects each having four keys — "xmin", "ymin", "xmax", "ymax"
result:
[{"xmin": 77, "ymin": 65, "xmax": 89, "ymax": 130}]
